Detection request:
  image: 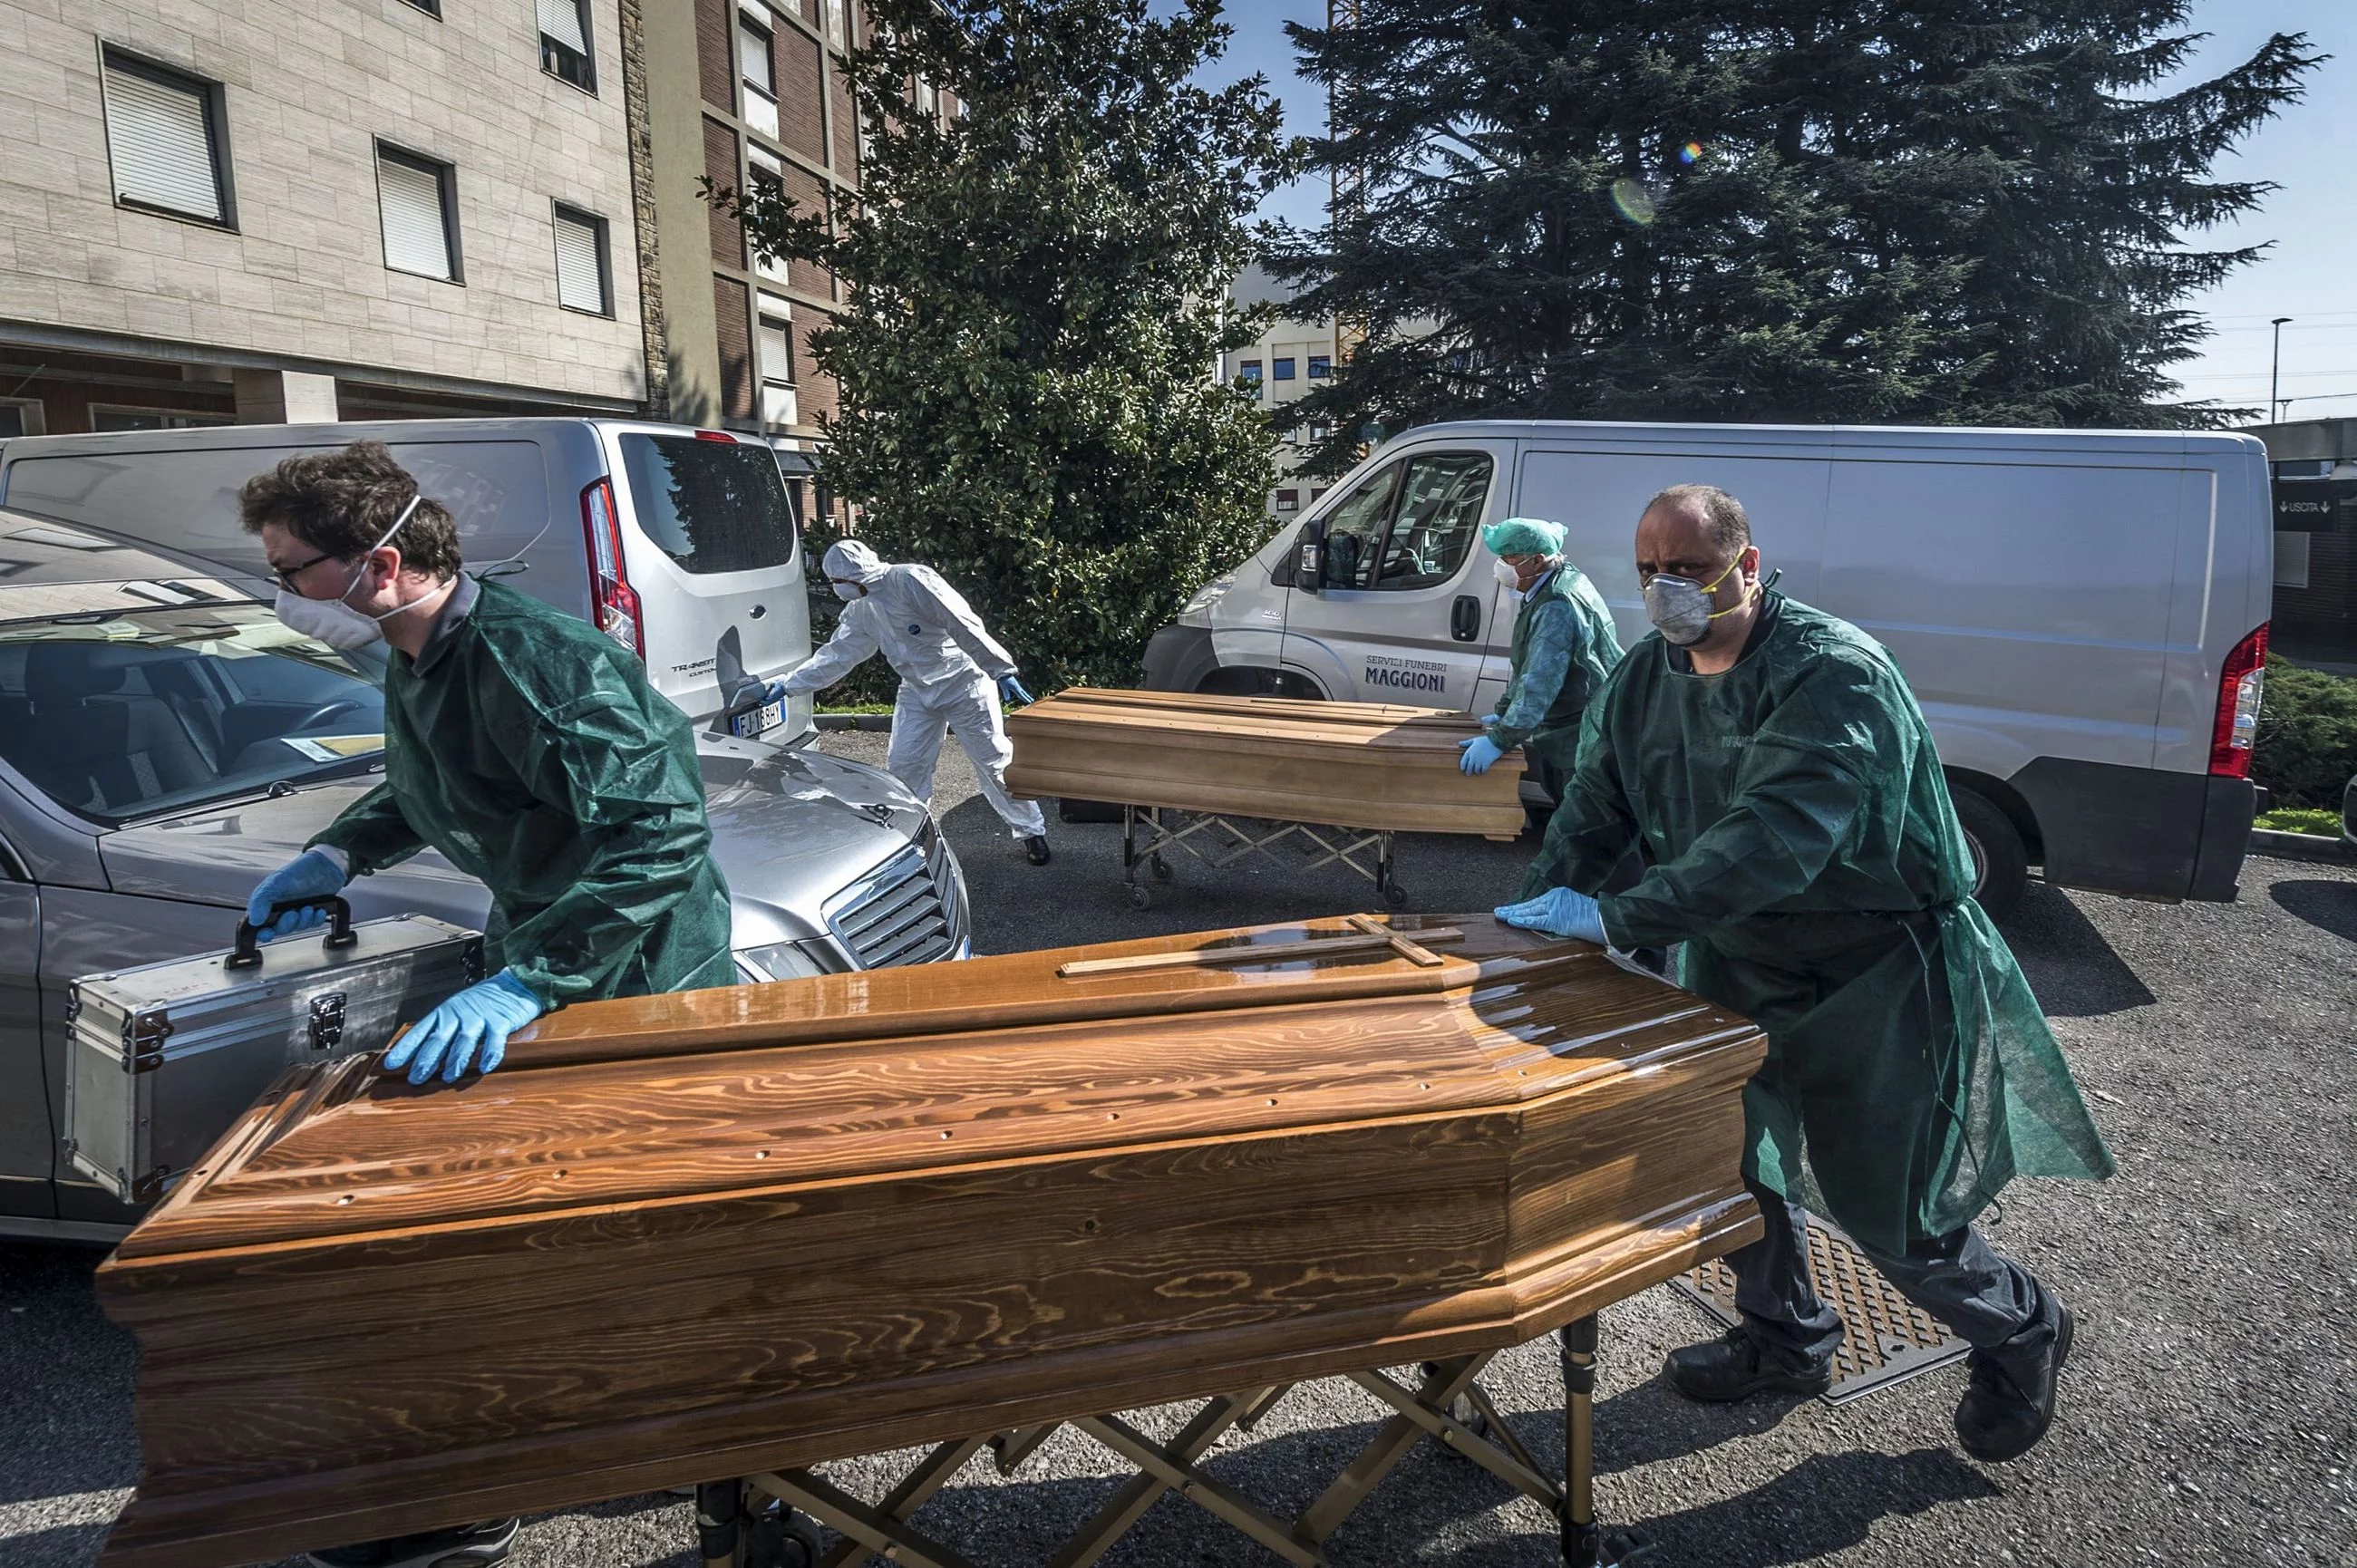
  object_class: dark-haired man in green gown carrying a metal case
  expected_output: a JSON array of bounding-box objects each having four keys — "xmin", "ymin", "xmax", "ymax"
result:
[{"xmin": 243, "ymin": 440, "xmax": 735, "ymax": 1568}]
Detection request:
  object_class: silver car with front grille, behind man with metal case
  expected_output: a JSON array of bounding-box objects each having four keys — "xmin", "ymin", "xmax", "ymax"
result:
[{"xmin": 0, "ymin": 509, "xmax": 966, "ymax": 1240}]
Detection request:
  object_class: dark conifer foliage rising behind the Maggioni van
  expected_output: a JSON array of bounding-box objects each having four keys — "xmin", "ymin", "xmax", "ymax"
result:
[{"xmin": 1275, "ymin": 0, "xmax": 2319, "ymax": 469}]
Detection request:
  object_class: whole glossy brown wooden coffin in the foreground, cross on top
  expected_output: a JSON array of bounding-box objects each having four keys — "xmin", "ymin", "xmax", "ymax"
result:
[{"xmin": 99, "ymin": 915, "xmax": 1765, "ymax": 1568}]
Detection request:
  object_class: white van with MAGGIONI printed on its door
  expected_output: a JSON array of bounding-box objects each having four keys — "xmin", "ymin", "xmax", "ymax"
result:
[{"xmin": 1146, "ymin": 420, "xmax": 2275, "ymax": 910}]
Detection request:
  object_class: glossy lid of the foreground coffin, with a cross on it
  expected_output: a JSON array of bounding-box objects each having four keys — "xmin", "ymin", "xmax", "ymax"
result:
[{"xmin": 118, "ymin": 915, "xmax": 1756, "ymax": 1266}]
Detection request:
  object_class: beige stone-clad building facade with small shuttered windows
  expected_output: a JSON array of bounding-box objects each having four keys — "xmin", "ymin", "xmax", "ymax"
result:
[{"xmin": 0, "ymin": 0, "xmax": 651, "ymax": 436}]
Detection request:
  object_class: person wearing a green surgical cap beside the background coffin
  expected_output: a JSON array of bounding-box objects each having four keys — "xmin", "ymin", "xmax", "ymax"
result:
[{"xmin": 1457, "ymin": 517, "xmax": 1622, "ymax": 799}]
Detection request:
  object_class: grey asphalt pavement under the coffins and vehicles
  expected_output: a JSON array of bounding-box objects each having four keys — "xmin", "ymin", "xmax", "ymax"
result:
[{"xmin": 0, "ymin": 733, "xmax": 2357, "ymax": 1568}]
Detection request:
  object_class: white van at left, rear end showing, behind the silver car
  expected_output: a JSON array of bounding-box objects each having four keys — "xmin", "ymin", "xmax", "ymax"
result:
[{"xmin": 0, "ymin": 417, "xmax": 810, "ymax": 740}]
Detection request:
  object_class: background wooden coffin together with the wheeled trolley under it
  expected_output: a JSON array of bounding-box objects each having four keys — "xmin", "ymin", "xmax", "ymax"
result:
[{"xmin": 1006, "ymin": 686, "xmax": 1523, "ymax": 910}]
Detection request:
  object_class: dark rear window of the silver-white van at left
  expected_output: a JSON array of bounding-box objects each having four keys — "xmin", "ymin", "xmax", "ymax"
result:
[{"xmin": 622, "ymin": 434, "xmax": 794, "ymax": 576}]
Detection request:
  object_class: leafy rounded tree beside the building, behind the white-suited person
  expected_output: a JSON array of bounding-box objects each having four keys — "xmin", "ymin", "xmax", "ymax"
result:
[{"xmin": 723, "ymin": 0, "xmax": 1285, "ymax": 691}]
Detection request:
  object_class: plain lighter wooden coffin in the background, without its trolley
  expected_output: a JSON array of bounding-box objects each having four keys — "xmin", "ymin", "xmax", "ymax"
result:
[{"xmin": 1006, "ymin": 686, "xmax": 1523, "ymax": 839}]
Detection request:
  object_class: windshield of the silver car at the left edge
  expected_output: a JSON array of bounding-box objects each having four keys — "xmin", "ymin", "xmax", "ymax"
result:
[{"xmin": 0, "ymin": 604, "xmax": 384, "ymax": 826}]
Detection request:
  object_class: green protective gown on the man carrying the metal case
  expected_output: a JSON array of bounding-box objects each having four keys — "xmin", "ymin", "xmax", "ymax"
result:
[{"xmin": 314, "ymin": 583, "xmax": 735, "ymax": 1007}]
